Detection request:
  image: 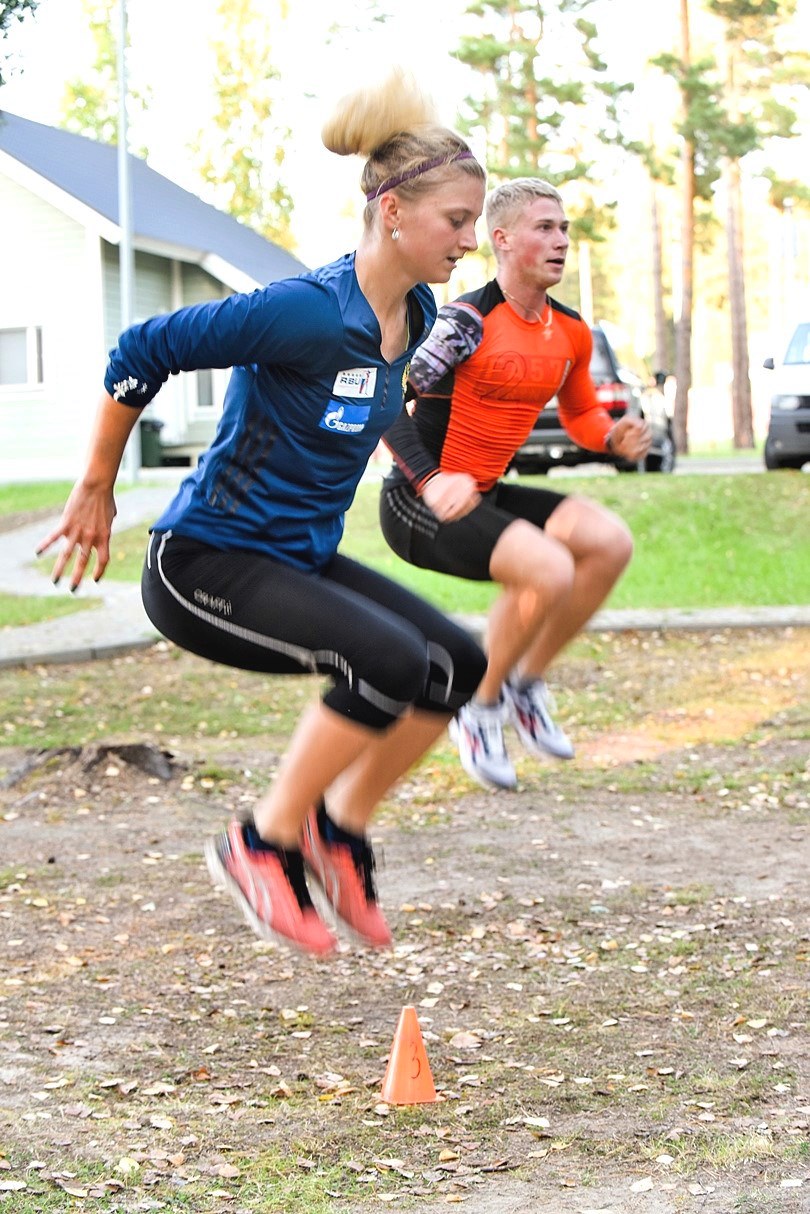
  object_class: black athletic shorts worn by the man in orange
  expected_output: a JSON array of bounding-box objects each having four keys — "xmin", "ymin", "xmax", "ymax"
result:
[{"xmin": 380, "ymin": 473, "xmax": 565, "ymax": 582}]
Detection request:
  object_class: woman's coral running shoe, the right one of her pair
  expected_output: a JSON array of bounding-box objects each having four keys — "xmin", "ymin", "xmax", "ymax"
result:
[{"xmin": 301, "ymin": 805, "xmax": 392, "ymax": 948}]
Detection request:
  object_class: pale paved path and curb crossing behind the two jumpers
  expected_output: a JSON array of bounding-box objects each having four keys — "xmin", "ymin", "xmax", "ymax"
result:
[{"xmin": 0, "ymin": 476, "xmax": 810, "ymax": 668}]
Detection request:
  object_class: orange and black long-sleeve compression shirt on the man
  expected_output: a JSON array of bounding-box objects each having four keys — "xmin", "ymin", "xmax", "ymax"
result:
[{"xmin": 385, "ymin": 279, "xmax": 613, "ymax": 492}]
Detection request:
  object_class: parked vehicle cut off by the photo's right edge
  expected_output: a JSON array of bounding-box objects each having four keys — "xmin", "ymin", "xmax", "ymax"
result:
[{"xmin": 764, "ymin": 320, "xmax": 810, "ymax": 471}]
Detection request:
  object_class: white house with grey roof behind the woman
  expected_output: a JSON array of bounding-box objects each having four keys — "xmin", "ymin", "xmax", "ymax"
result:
[{"xmin": 0, "ymin": 110, "xmax": 306, "ymax": 482}]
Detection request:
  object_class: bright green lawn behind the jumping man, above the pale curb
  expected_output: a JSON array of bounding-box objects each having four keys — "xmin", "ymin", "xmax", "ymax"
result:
[{"xmin": 15, "ymin": 472, "xmax": 810, "ymax": 613}]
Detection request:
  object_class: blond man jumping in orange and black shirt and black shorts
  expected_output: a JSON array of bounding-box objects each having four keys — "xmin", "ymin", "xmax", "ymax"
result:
[{"xmin": 380, "ymin": 177, "xmax": 650, "ymax": 788}]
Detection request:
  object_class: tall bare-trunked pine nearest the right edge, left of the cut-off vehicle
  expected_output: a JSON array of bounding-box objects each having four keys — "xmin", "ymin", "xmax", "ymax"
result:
[{"xmin": 707, "ymin": 0, "xmax": 810, "ymax": 447}]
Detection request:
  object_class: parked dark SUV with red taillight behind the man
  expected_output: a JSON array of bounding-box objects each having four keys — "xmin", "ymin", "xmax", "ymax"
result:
[{"xmin": 511, "ymin": 328, "xmax": 675, "ymax": 473}]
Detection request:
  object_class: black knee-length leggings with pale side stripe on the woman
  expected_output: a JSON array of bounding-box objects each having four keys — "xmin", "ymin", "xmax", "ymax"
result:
[{"xmin": 141, "ymin": 532, "xmax": 486, "ymax": 730}]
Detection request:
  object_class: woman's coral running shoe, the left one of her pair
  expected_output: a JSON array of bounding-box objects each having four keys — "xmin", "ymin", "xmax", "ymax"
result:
[{"xmin": 205, "ymin": 822, "xmax": 338, "ymax": 957}]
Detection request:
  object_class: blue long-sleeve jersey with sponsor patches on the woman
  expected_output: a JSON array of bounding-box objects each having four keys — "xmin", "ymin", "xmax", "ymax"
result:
[{"xmin": 104, "ymin": 254, "xmax": 436, "ymax": 571}]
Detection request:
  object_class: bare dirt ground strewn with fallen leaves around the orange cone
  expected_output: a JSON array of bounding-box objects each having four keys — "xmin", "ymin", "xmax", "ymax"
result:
[{"xmin": 0, "ymin": 630, "xmax": 810, "ymax": 1214}]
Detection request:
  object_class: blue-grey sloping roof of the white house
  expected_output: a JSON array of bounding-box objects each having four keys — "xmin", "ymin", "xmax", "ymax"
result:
[{"xmin": 0, "ymin": 110, "xmax": 307, "ymax": 283}]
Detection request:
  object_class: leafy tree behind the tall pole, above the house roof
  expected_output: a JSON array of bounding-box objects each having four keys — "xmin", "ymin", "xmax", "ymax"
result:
[{"xmin": 62, "ymin": 0, "xmax": 151, "ymax": 157}]
